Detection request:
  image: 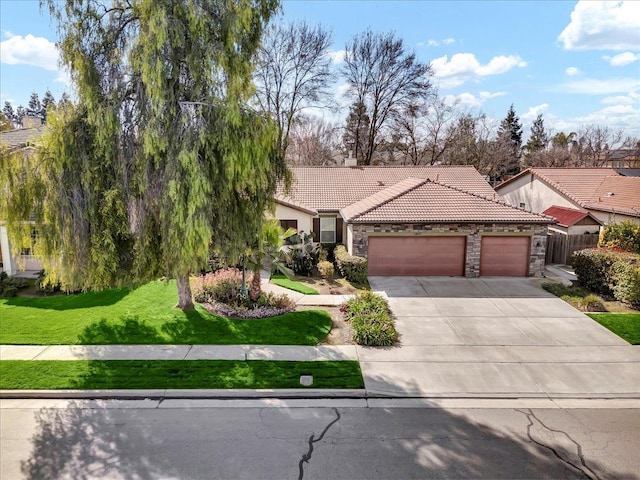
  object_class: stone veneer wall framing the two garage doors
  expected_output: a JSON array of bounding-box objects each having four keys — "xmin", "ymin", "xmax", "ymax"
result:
[{"xmin": 351, "ymin": 223, "xmax": 547, "ymax": 277}]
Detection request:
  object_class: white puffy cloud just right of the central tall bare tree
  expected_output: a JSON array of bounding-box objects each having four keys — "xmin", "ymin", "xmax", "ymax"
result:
[{"xmin": 431, "ymin": 53, "xmax": 527, "ymax": 88}]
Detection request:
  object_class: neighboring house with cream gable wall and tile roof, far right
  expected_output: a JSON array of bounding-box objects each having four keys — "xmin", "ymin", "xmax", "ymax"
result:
[{"xmin": 496, "ymin": 168, "xmax": 640, "ymax": 224}]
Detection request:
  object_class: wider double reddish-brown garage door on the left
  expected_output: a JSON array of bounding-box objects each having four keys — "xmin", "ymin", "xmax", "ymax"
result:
[{"xmin": 367, "ymin": 237, "xmax": 466, "ymax": 276}]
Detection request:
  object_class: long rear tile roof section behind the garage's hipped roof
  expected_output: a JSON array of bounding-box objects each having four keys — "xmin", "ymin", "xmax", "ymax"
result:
[{"xmin": 279, "ymin": 165, "xmax": 495, "ymax": 211}]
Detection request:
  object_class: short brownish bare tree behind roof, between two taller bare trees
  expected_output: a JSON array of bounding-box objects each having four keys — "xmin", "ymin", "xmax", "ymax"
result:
[{"xmin": 287, "ymin": 115, "xmax": 341, "ymax": 166}]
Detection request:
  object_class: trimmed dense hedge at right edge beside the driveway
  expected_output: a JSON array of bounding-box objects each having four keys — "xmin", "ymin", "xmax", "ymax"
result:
[{"xmin": 571, "ymin": 248, "xmax": 640, "ymax": 307}]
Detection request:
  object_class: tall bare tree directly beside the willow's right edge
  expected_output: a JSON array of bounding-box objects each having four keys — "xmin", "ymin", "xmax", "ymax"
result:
[{"xmin": 255, "ymin": 22, "xmax": 332, "ymax": 156}]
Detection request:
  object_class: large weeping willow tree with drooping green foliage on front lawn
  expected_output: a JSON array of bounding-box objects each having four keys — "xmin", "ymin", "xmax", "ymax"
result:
[{"xmin": 0, "ymin": 0, "xmax": 288, "ymax": 310}]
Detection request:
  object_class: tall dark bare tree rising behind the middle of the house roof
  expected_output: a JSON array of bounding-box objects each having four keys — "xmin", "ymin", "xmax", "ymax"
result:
[{"xmin": 342, "ymin": 30, "xmax": 432, "ymax": 165}]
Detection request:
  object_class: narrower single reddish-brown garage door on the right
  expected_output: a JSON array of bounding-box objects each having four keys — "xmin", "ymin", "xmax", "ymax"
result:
[{"xmin": 480, "ymin": 236, "xmax": 531, "ymax": 277}]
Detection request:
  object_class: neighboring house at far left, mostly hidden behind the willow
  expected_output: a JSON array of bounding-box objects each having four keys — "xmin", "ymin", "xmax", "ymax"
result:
[{"xmin": 0, "ymin": 126, "xmax": 44, "ymax": 275}]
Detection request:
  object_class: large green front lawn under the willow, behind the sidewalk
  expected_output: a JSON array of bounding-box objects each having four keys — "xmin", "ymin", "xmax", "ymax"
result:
[{"xmin": 0, "ymin": 281, "xmax": 331, "ymax": 345}]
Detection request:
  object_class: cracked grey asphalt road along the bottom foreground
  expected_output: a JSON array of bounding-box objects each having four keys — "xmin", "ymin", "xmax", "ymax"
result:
[{"xmin": 0, "ymin": 400, "xmax": 640, "ymax": 480}]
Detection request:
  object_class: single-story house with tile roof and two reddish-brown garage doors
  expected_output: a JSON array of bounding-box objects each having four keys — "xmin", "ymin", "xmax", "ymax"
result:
[{"xmin": 275, "ymin": 166, "xmax": 555, "ymax": 277}]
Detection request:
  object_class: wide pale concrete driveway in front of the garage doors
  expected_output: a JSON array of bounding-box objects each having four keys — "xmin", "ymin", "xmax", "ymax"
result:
[{"xmin": 358, "ymin": 277, "xmax": 640, "ymax": 398}]
